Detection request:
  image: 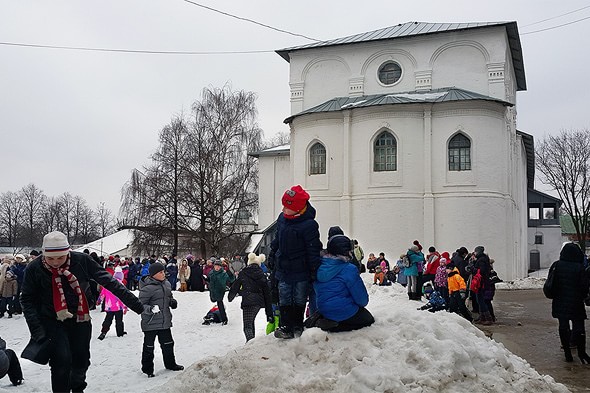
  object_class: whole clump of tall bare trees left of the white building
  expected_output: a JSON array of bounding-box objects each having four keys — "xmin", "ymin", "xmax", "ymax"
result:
[{"xmin": 121, "ymin": 86, "xmax": 262, "ymax": 256}]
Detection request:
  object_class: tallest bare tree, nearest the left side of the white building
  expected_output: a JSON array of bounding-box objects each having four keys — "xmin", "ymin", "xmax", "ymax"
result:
[{"xmin": 187, "ymin": 85, "xmax": 262, "ymax": 255}]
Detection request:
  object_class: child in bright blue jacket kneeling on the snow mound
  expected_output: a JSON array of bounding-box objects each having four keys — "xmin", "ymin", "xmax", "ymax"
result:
[{"xmin": 313, "ymin": 235, "xmax": 375, "ymax": 332}]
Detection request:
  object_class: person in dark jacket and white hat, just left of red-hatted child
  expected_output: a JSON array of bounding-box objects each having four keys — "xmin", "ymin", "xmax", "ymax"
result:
[{"xmin": 228, "ymin": 253, "xmax": 274, "ymax": 342}]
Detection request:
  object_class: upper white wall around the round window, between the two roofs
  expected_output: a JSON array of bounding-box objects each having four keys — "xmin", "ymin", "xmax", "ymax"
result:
[{"xmin": 289, "ymin": 27, "xmax": 515, "ymax": 114}]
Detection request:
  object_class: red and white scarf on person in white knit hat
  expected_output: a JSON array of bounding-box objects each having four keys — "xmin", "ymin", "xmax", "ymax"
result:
[{"xmin": 43, "ymin": 257, "xmax": 90, "ymax": 322}]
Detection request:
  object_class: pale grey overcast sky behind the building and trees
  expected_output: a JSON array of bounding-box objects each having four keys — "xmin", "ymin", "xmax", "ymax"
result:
[{"xmin": 0, "ymin": 0, "xmax": 590, "ymax": 214}]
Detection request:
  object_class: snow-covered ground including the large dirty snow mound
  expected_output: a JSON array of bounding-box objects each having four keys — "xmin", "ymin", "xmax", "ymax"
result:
[{"xmin": 0, "ymin": 274, "xmax": 568, "ymax": 393}]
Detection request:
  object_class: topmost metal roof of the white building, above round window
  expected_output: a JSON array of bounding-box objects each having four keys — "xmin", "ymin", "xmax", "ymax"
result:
[{"xmin": 276, "ymin": 22, "xmax": 526, "ymax": 90}]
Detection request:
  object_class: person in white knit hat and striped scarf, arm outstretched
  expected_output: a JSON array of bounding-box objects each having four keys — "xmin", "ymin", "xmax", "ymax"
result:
[{"xmin": 21, "ymin": 231, "xmax": 143, "ymax": 392}]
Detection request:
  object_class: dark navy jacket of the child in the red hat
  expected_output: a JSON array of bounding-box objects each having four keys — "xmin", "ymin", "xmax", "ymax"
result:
[{"xmin": 270, "ymin": 202, "xmax": 322, "ymax": 283}]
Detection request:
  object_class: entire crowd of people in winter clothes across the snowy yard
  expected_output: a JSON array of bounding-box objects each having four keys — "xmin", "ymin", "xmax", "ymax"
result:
[{"xmin": 0, "ymin": 186, "xmax": 590, "ymax": 392}]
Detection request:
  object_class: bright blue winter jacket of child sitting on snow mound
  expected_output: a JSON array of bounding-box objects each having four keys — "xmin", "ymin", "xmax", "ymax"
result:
[{"xmin": 313, "ymin": 255, "xmax": 369, "ymax": 322}]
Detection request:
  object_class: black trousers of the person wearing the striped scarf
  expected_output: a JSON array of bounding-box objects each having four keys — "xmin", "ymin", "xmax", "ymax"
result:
[{"xmin": 46, "ymin": 318, "xmax": 92, "ymax": 392}]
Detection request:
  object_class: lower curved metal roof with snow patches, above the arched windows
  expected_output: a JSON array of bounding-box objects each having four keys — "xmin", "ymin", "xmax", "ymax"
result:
[{"xmin": 284, "ymin": 87, "xmax": 513, "ymax": 124}]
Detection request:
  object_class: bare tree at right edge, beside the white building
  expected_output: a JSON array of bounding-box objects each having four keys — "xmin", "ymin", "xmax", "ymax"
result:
[{"xmin": 535, "ymin": 129, "xmax": 590, "ymax": 250}]
